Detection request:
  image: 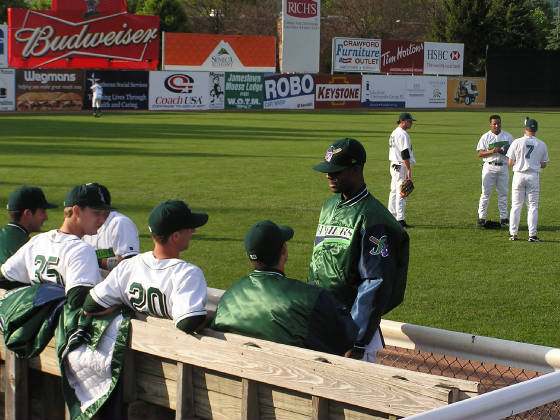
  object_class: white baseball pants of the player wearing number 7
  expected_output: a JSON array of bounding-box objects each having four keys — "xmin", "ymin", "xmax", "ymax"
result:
[{"xmin": 509, "ymin": 172, "xmax": 540, "ymax": 236}]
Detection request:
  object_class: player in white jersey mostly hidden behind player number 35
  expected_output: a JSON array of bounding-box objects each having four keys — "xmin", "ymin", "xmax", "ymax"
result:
[{"xmin": 83, "ymin": 184, "xmax": 140, "ymax": 277}]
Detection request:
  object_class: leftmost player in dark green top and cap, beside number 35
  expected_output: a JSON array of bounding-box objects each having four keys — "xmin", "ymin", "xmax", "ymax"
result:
[{"xmin": 0, "ymin": 185, "xmax": 58, "ymax": 264}]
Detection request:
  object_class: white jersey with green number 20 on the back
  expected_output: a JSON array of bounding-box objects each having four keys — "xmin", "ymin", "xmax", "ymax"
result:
[{"xmin": 90, "ymin": 251, "xmax": 206, "ymax": 325}]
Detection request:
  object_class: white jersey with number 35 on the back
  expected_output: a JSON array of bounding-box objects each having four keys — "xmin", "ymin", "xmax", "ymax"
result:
[{"xmin": 1, "ymin": 229, "xmax": 101, "ymax": 293}]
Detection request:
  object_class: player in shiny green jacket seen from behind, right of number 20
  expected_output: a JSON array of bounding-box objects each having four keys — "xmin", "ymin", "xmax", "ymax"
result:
[{"xmin": 213, "ymin": 220, "xmax": 358, "ymax": 355}]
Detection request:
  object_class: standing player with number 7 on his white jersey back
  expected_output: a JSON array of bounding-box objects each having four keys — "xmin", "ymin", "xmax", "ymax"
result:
[{"xmin": 506, "ymin": 118, "xmax": 548, "ymax": 242}]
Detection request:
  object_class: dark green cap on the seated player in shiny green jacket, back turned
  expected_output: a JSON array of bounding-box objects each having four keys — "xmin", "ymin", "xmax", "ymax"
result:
[{"xmin": 245, "ymin": 220, "xmax": 294, "ymax": 265}]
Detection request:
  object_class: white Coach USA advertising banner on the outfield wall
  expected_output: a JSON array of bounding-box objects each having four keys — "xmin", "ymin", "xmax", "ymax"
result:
[{"xmin": 149, "ymin": 71, "xmax": 219, "ymax": 111}]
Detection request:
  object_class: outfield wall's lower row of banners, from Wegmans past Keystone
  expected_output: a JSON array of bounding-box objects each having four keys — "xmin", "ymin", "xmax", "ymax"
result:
[{"xmin": 0, "ymin": 69, "xmax": 486, "ymax": 112}]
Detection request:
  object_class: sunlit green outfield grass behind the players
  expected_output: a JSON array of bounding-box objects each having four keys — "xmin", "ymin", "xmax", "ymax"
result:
[{"xmin": 0, "ymin": 110, "xmax": 560, "ymax": 347}]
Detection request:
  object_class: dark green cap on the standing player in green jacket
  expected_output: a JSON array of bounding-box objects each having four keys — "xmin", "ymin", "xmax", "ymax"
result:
[{"xmin": 313, "ymin": 137, "xmax": 366, "ymax": 173}]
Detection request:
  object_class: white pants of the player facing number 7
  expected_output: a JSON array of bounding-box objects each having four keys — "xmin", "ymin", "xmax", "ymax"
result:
[{"xmin": 478, "ymin": 162, "xmax": 509, "ymax": 219}]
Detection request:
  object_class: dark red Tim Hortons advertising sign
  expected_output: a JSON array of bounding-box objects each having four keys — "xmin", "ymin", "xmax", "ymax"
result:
[{"xmin": 381, "ymin": 40, "xmax": 424, "ymax": 74}]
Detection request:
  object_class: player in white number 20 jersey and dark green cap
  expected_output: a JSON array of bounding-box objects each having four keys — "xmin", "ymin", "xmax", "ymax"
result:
[{"xmin": 84, "ymin": 200, "xmax": 208, "ymax": 333}]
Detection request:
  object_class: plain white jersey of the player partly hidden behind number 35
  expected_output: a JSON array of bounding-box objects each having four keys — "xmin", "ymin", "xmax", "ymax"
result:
[{"xmin": 83, "ymin": 211, "xmax": 140, "ymax": 258}]
